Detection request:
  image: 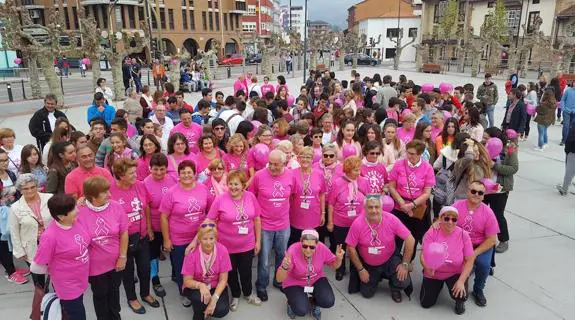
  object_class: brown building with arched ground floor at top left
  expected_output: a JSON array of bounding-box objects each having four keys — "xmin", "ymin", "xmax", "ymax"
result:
[{"xmin": 20, "ymin": 0, "xmax": 247, "ymax": 55}]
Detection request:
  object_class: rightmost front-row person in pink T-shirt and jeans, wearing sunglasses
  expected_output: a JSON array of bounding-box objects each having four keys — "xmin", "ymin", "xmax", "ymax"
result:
[{"xmin": 453, "ymin": 181, "xmax": 499, "ymax": 307}]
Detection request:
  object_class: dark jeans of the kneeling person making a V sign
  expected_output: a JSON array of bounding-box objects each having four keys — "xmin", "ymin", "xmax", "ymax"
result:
[{"xmin": 284, "ymin": 277, "xmax": 335, "ymax": 317}]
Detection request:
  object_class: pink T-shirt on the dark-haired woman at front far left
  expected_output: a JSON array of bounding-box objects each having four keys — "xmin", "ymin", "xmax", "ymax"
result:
[{"xmin": 34, "ymin": 221, "xmax": 90, "ymax": 300}]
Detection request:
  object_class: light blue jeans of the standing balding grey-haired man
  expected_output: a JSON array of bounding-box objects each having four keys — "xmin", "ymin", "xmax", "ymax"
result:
[{"xmin": 256, "ymin": 228, "xmax": 290, "ymax": 292}]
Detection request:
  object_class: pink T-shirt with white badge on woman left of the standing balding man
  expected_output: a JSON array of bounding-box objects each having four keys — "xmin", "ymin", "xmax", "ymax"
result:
[{"xmin": 208, "ymin": 191, "xmax": 261, "ymax": 253}]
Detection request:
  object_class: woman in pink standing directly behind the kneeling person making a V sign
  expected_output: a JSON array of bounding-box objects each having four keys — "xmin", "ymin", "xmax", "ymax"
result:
[{"xmin": 288, "ymin": 147, "xmax": 326, "ymax": 246}]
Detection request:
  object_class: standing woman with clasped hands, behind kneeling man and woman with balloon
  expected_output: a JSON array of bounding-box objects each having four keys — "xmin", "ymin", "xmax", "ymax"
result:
[{"xmin": 388, "ymin": 140, "xmax": 435, "ymax": 258}]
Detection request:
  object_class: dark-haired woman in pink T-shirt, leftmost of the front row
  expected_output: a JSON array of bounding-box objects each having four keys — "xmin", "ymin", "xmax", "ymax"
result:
[{"xmin": 31, "ymin": 194, "xmax": 90, "ymax": 320}]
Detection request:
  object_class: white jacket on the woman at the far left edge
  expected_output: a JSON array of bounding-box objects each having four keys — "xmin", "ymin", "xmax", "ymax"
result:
[{"xmin": 8, "ymin": 193, "xmax": 52, "ymax": 262}]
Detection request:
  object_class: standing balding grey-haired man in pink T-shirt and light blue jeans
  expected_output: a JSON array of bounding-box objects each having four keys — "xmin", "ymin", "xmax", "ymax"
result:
[{"xmin": 250, "ymin": 150, "xmax": 295, "ymax": 301}]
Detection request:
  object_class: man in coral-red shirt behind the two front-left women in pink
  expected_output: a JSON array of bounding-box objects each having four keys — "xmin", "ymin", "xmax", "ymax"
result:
[{"xmin": 64, "ymin": 146, "xmax": 114, "ymax": 199}]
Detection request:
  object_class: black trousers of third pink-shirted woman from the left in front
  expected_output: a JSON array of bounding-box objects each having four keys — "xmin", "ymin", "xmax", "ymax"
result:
[{"xmin": 122, "ymin": 237, "xmax": 150, "ymax": 301}]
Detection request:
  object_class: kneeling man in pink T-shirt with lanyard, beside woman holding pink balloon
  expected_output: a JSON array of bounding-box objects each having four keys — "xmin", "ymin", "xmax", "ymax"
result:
[{"xmin": 345, "ymin": 194, "xmax": 415, "ymax": 303}]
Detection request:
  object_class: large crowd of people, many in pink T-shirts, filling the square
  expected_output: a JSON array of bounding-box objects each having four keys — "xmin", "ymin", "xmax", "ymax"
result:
[{"xmin": 0, "ymin": 65, "xmax": 575, "ymax": 320}]
